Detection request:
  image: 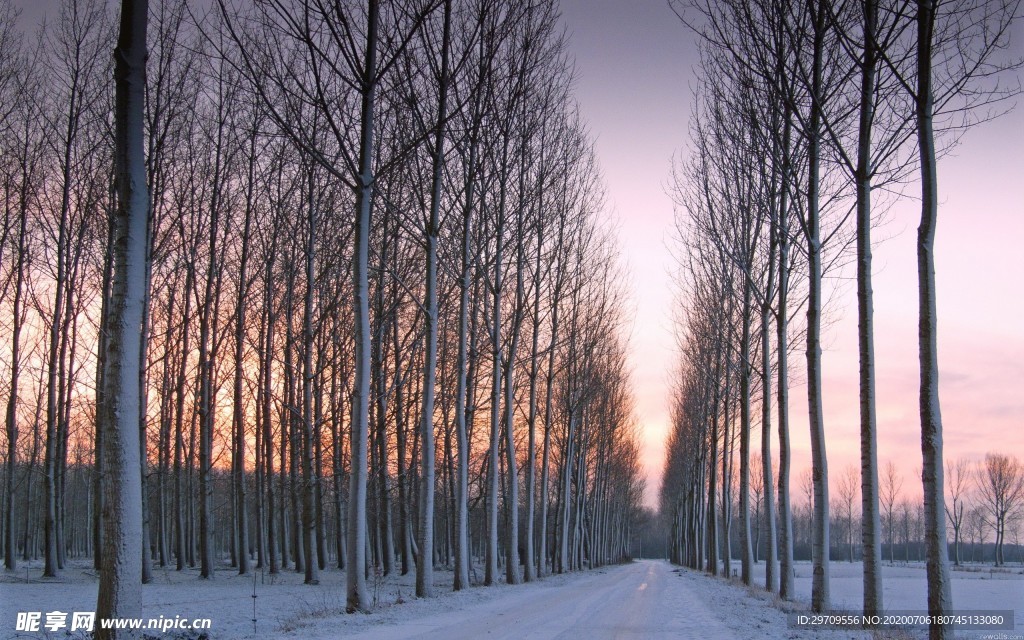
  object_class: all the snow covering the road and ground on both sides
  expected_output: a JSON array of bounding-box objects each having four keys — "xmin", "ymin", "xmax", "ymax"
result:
[{"xmin": 0, "ymin": 560, "xmax": 1024, "ymax": 640}]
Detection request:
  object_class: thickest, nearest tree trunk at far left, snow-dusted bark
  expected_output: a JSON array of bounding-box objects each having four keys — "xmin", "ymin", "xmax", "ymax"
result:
[{"xmin": 96, "ymin": 0, "xmax": 148, "ymax": 638}]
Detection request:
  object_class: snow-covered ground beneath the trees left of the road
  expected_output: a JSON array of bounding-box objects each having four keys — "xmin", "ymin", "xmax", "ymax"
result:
[{"xmin": 0, "ymin": 561, "xmax": 516, "ymax": 640}]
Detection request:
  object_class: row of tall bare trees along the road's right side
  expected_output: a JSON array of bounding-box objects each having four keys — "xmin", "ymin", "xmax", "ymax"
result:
[{"xmin": 662, "ymin": 0, "xmax": 1019, "ymax": 638}]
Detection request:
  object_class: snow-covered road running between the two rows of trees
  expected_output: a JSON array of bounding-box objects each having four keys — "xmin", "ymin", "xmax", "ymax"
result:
[{"xmin": 335, "ymin": 560, "xmax": 863, "ymax": 640}]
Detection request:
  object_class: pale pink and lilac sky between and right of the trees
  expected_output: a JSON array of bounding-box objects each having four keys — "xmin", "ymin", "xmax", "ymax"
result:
[{"xmin": 562, "ymin": 0, "xmax": 1024, "ymax": 506}]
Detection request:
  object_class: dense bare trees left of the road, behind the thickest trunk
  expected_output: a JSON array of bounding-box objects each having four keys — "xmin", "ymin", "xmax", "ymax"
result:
[{"xmin": 0, "ymin": 0, "xmax": 643, "ymax": 611}]
